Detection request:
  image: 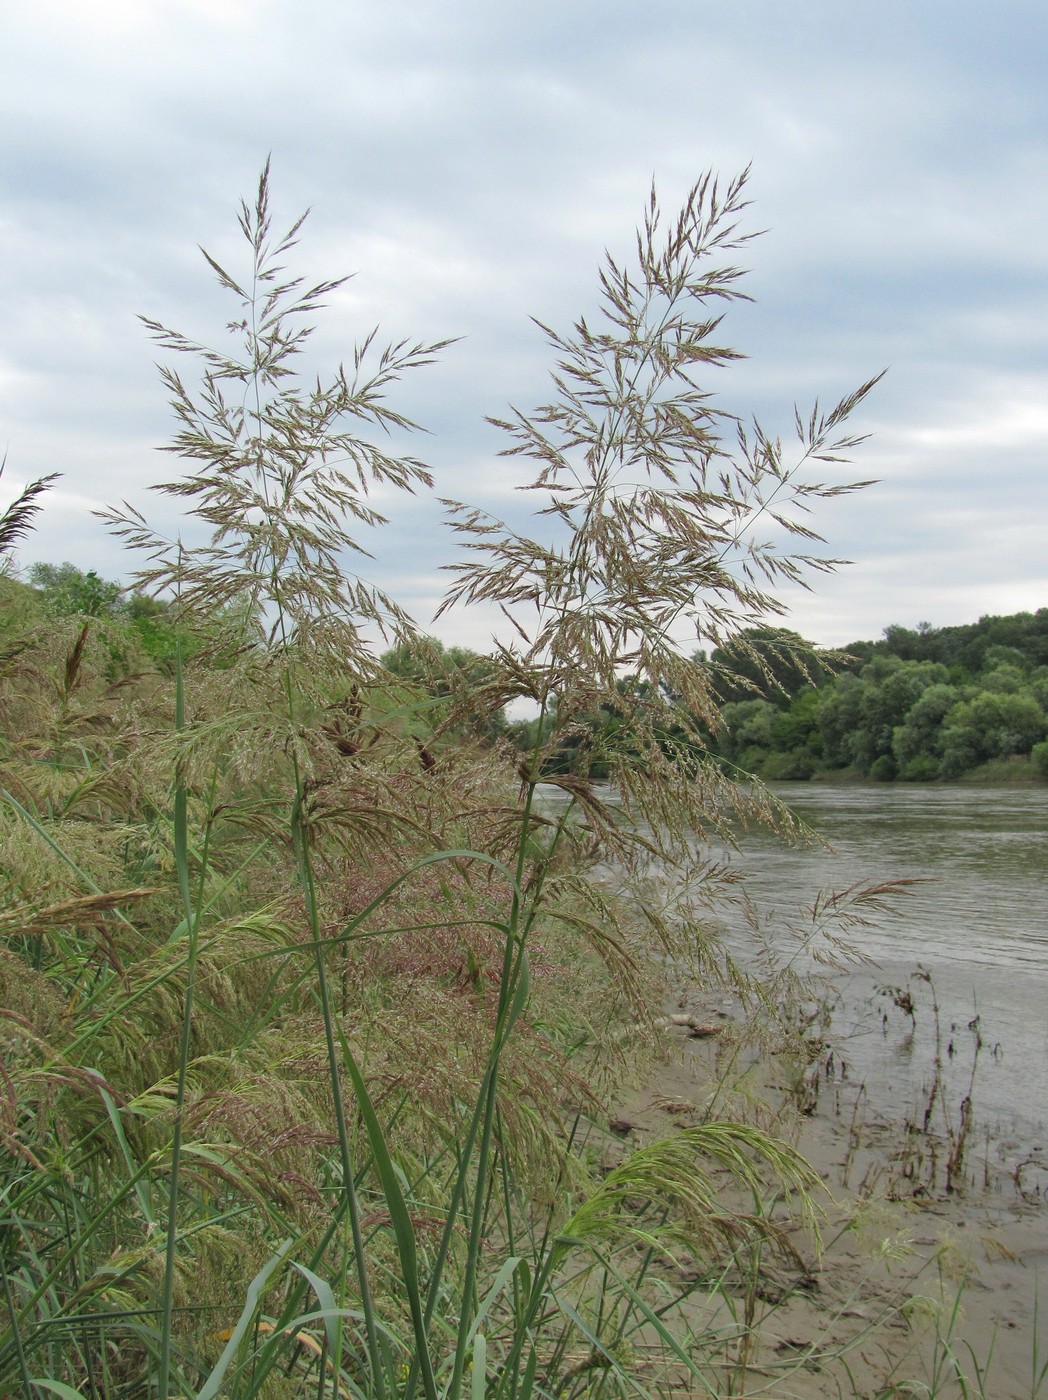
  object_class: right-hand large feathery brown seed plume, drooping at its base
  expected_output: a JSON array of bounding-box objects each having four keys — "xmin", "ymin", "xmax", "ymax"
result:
[{"xmin": 444, "ymin": 174, "xmax": 879, "ymax": 858}]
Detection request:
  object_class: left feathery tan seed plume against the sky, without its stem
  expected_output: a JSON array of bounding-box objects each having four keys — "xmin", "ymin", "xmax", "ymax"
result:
[{"xmin": 104, "ymin": 162, "xmax": 451, "ymax": 661}]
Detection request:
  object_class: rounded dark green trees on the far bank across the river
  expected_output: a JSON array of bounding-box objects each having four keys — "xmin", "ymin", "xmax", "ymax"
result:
[{"xmin": 503, "ymin": 608, "xmax": 1048, "ymax": 783}]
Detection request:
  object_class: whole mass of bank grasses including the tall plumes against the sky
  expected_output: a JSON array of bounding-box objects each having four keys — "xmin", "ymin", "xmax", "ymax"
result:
[{"xmin": 0, "ymin": 171, "xmax": 962, "ymax": 1400}]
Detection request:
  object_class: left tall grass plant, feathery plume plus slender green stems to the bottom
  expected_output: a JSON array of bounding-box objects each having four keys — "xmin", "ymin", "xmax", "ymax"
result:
[{"xmin": 106, "ymin": 165, "xmax": 456, "ymax": 1397}]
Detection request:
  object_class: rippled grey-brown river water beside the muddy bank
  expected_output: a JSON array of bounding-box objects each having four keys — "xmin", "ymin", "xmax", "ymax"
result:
[{"xmin": 702, "ymin": 783, "xmax": 1048, "ymax": 1161}]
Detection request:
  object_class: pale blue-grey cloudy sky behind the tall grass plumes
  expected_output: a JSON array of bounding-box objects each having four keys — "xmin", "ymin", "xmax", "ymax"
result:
[{"xmin": 0, "ymin": 0, "xmax": 1048, "ymax": 647}]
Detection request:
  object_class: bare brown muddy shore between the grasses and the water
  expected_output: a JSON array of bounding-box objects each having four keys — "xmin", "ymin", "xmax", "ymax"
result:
[{"xmin": 607, "ymin": 1008, "xmax": 1048, "ymax": 1400}]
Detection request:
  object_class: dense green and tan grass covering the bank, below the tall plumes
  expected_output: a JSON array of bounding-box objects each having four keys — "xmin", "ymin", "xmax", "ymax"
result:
[{"xmin": 0, "ymin": 593, "xmax": 833, "ymax": 1396}]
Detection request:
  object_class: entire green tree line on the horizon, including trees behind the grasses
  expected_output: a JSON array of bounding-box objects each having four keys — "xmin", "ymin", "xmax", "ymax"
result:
[{"xmin": 16, "ymin": 563, "xmax": 1048, "ymax": 783}]
